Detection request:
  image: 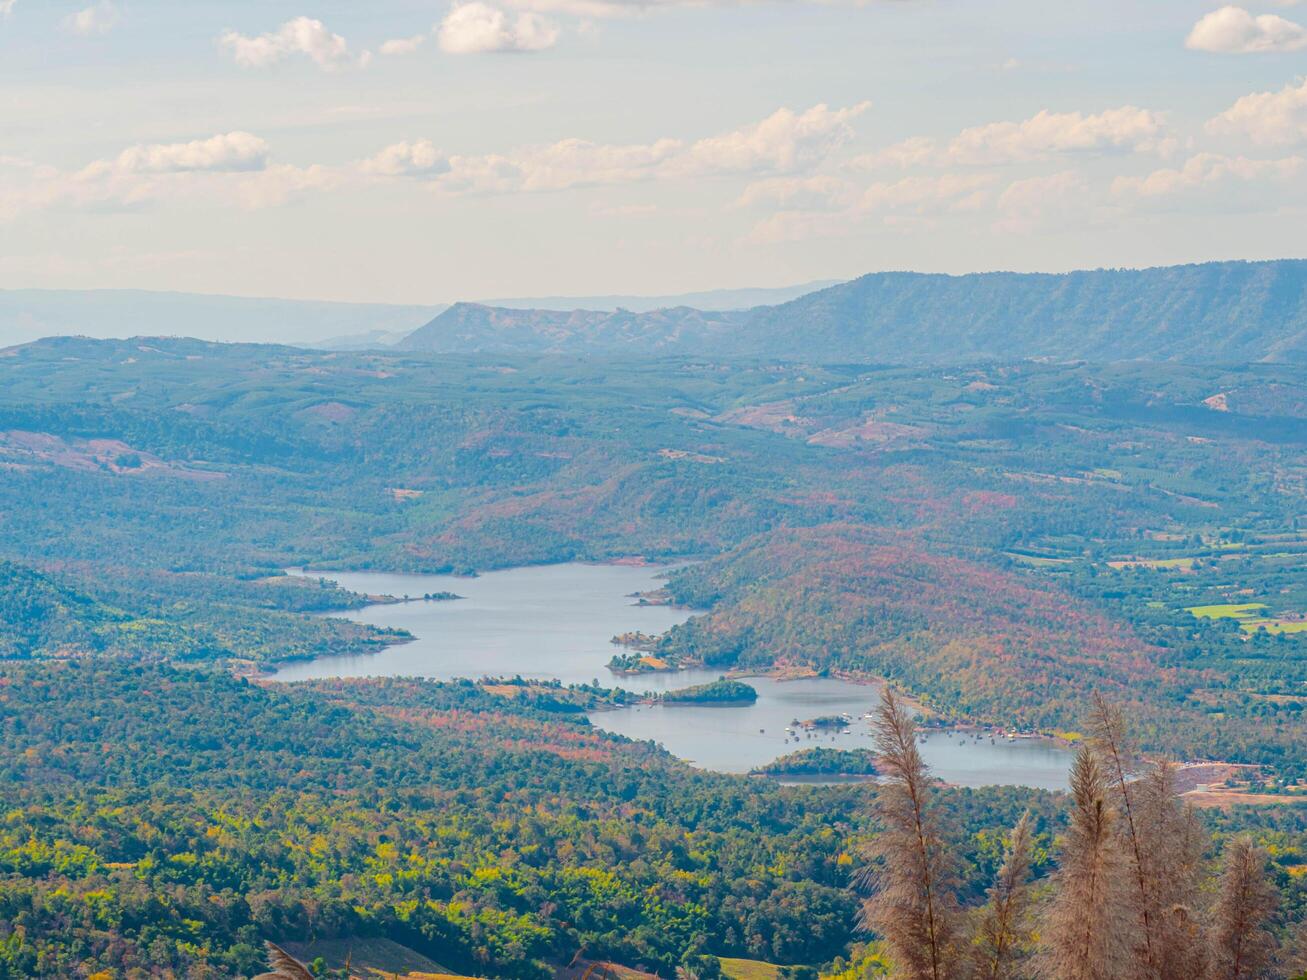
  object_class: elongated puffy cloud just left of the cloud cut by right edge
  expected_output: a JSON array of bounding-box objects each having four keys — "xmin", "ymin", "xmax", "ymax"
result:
[{"xmin": 945, "ymin": 106, "xmax": 1168, "ymax": 165}]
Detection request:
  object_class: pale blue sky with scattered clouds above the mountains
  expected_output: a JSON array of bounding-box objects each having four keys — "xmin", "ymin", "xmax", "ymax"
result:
[{"xmin": 0, "ymin": 0, "xmax": 1307, "ymax": 303}]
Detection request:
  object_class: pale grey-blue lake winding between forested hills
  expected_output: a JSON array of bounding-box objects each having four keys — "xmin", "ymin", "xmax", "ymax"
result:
[{"xmin": 267, "ymin": 563, "xmax": 1070, "ymax": 789}]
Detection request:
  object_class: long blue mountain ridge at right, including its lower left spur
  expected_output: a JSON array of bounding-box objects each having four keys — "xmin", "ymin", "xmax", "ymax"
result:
[{"xmin": 403, "ymin": 260, "xmax": 1307, "ymax": 363}]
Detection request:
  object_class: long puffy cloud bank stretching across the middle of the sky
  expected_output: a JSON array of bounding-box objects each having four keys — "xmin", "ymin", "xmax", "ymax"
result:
[{"xmin": 379, "ymin": 103, "xmax": 867, "ymax": 193}]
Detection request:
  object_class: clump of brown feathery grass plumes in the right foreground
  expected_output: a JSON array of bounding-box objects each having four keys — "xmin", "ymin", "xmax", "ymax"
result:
[{"xmin": 864, "ymin": 690, "xmax": 1307, "ymax": 980}]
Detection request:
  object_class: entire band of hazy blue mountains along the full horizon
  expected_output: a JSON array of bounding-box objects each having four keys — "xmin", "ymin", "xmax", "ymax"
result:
[{"xmin": 0, "ymin": 260, "xmax": 1307, "ymax": 363}]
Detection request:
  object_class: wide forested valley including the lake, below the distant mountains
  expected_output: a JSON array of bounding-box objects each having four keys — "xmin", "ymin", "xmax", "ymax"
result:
[{"xmin": 0, "ymin": 327, "xmax": 1307, "ymax": 977}]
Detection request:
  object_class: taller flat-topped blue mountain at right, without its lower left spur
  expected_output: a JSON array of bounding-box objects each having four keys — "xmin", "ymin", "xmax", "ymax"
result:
[{"xmin": 748, "ymin": 260, "xmax": 1307, "ymax": 362}]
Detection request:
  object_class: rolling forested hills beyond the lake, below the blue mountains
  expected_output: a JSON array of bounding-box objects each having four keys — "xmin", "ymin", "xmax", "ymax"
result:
[{"xmin": 0, "ymin": 338, "xmax": 1307, "ymax": 775}]
